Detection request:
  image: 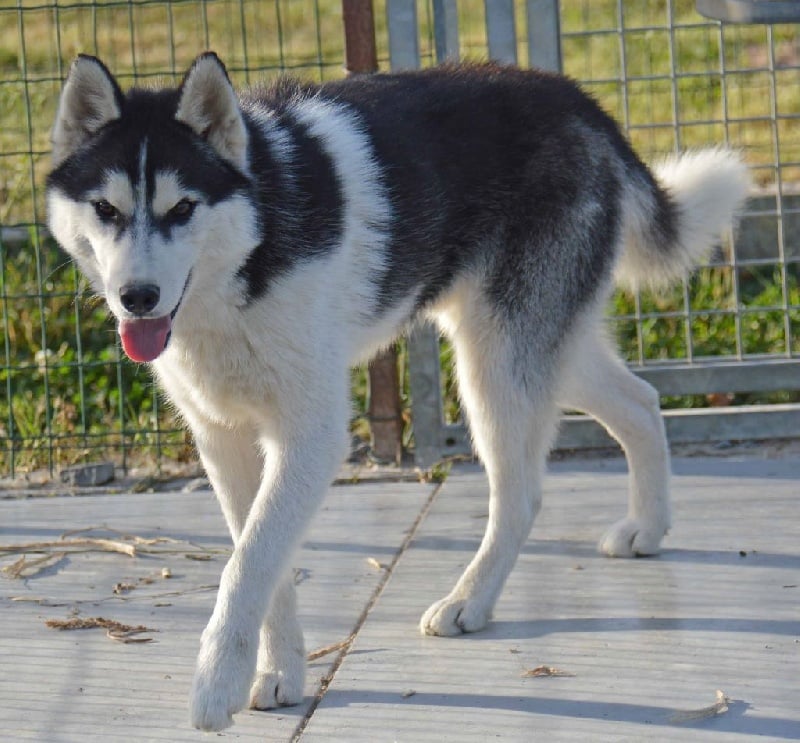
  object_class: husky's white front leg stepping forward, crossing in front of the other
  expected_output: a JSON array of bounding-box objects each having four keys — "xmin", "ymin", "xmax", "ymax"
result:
[{"xmin": 190, "ymin": 418, "xmax": 347, "ymax": 730}]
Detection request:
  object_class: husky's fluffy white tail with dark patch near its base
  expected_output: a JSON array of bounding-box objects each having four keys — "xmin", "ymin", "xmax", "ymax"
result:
[{"xmin": 615, "ymin": 148, "xmax": 750, "ymax": 288}]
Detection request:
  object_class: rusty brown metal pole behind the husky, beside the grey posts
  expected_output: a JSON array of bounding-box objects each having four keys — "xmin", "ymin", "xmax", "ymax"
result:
[{"xmin": 342, "ymin": 0, "xmax": 403, "ymax": 464}]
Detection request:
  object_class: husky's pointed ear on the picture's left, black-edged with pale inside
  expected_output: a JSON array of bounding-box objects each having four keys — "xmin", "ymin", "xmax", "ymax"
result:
[{"xmin": 51, "ymin": 54, "xmax": 124, "ymax": 167}]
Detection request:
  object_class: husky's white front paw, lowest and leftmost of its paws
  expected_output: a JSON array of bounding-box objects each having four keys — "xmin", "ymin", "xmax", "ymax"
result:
[{"xmin": 189, "ymin": 631, "xmax": 257, "ymax": 730}]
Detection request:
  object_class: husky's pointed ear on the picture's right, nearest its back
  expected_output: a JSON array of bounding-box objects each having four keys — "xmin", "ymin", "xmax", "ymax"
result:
[{"xmin": 175, "ymin": 52, "xmax": 248, "ymax": 173}]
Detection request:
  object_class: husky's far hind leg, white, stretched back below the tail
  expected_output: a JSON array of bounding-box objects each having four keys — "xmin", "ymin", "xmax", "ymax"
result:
[{"xmin": 558, "ymin": 326, "xmax": 670, "ymax": 557}]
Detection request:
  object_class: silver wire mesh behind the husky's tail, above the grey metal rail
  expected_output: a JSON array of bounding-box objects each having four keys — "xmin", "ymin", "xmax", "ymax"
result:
[{"xmin": 563, "ymin": 3, "xmax": 800, "ymax": 370}]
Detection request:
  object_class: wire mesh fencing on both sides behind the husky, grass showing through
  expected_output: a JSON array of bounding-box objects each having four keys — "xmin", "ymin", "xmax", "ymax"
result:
[{"xmin": 0, "ymin": 0, "xmax": 800, "ymax": 475}]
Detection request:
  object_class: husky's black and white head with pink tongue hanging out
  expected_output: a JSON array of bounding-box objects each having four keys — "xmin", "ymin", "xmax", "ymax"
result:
[{"xmin": 47, "ymin": 53, "xmax": 257, "ymax": 361}]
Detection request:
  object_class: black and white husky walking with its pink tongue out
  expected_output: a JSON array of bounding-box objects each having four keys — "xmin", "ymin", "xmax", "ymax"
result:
[{"xmin": 47, "ymin": 53, "xmax": 748, "ymax": 730}]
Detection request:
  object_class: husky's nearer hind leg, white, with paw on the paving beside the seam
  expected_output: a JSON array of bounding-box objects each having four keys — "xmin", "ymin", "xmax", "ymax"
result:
[{"xmin": 420, "ymin": 294, "xmax": 556, "ymax": 636}]
